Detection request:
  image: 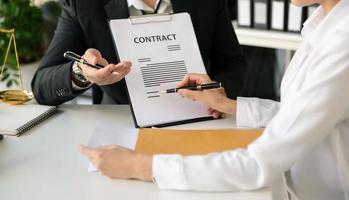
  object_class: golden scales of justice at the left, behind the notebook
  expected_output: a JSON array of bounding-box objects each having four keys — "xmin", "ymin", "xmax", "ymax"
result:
[{"xmin": 0, "ymin": 28, "xmax": 33, "ymax": 105}]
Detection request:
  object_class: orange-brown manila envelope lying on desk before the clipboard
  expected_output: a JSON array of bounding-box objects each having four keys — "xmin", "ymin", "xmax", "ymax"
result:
[{"xmin": 136, "ymin": 128, "xmax": 263, "ymax": 155}]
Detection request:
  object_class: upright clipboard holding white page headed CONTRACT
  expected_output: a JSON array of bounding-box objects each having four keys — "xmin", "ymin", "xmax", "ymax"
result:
[{"xmin": 109, "ymin": 13, "xmax": 213, "ymax": 128}]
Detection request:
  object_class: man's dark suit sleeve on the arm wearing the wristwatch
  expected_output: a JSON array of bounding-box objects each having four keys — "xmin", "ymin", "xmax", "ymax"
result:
[{"xmin": 31, "ymin": 0, "xmax": 86, "ymax": 105}]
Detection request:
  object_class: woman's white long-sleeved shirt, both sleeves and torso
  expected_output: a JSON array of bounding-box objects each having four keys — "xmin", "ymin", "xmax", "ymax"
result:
[{"xmin": 153, "ymin": 0, "xmax": 349, "ymax": 200}]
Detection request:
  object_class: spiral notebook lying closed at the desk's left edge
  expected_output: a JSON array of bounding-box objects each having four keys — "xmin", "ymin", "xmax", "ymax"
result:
[{"xmin": 0, "ymin": 103, "xmax": 57, "ymax": 136}]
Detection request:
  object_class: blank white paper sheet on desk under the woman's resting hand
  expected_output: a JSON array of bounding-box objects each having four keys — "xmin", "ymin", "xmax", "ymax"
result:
[{"xmin": 87, "ymin": 122, "xmax": 138, "ymax": 172}]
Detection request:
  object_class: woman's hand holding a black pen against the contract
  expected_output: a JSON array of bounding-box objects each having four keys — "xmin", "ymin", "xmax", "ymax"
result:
[{"xmin": 177, "ymin": 74, "xmax": 236, "ymax": 118}]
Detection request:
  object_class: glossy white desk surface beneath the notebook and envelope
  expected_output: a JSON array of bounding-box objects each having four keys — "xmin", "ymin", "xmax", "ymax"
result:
[{"xmin": 0, "ymin": 105, "xmax": 272, "ymax": 200}]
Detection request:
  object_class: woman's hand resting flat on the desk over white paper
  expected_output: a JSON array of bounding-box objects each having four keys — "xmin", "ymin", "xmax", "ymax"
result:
[{"xmin": 80, "ymin": 146, "xmax": 153, "ymax": 181}]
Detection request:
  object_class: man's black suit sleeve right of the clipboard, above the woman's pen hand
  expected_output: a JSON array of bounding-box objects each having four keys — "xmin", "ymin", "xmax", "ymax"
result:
[{"xmin": 208, "ymin": 0, "xmax": 247, "ymax": 99}]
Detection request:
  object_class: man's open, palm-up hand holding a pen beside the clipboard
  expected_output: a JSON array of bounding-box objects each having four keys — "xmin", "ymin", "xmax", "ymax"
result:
[{"xmin": 79, "ymin": 49, "xmax": 132, "ymax": 86}]
